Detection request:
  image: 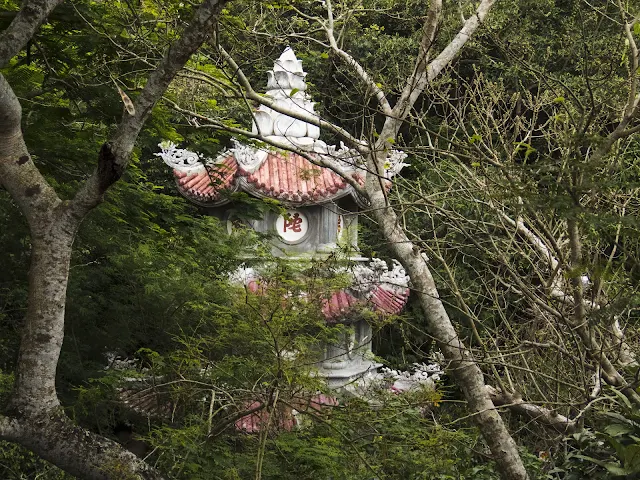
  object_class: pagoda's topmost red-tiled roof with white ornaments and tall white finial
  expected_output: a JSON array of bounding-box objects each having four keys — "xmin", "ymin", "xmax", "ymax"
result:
[{"xmin": 156, "ymin": 48, "xmax": 406, "ymax": 206}]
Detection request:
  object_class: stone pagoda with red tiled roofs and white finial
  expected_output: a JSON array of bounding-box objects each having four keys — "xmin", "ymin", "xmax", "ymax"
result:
[{"xmin": 156, "ymin": 48, "xmax": 409, "ymax": 388}]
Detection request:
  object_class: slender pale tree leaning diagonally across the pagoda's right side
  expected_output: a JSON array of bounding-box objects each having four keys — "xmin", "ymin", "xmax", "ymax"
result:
[{"xmin": 161, "ymin": 1, "xmax": 540, "ymax": 479}]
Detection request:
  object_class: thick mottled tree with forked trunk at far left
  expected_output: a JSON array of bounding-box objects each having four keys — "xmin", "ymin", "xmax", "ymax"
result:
[{"xmin": 0, "ymin": 0, "xmax": 230, "ymax": 478}]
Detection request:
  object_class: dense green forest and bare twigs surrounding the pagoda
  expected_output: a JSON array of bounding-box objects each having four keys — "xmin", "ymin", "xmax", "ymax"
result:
[{"xmin": 0, "ymin": 0, "xmax": 640, "ymax": 480}]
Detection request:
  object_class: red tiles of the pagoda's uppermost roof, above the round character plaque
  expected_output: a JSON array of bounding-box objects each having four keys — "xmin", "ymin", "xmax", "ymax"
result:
[{"xmin": 174, "ymin": 152, "xmax": 362, "ymax": 204}]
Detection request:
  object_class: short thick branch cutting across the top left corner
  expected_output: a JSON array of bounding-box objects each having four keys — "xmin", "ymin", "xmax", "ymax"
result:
[{"xmin": 0, "ymin": 0, "xmax": 63, "ymax": 68}]
